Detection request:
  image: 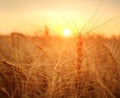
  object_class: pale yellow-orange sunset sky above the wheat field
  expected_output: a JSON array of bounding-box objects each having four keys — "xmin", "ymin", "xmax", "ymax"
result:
[{"xmin": 0, "ymin": 0, "xmax": 120, "ymax": 35}]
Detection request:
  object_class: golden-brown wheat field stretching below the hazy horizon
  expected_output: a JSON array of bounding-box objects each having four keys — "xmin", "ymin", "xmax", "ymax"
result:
[{"xmin": 0, "ymin": 34, "xmax": 120, "ymax": 98}]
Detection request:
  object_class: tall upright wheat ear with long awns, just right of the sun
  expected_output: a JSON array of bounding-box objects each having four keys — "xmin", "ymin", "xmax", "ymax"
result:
[{"xmin": 76, "ymin": 3, "xmax": 120, "ymax": 96}]
